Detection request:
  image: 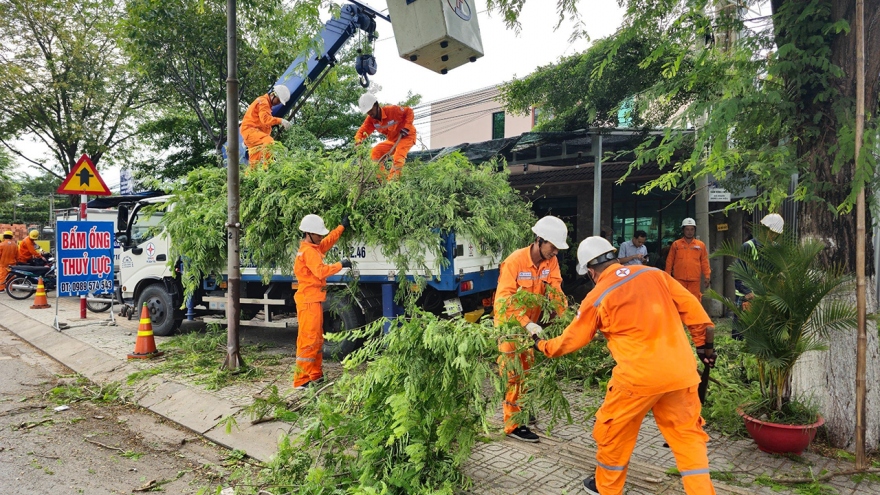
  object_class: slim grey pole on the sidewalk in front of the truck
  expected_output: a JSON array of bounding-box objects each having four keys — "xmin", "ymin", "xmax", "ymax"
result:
[{"xmin": 223, "ymin": 0, "xmax": 244, "ymax": 371}]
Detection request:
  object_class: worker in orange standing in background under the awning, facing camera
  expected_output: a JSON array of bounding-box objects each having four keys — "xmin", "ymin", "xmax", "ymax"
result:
[{"xmin": 666, "ymin": 218, "xmax": 712, "ymax": 300}]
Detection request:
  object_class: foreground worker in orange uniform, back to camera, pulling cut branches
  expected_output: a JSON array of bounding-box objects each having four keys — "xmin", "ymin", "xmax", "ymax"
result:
[{"xmin": 532, "ymin": 236, "xmax": 715, "ymax": 495}]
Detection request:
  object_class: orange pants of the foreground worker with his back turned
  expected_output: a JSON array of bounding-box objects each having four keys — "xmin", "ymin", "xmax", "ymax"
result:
[{"xmin": 593, "ymin": 378, "xmax": 715, "ymax": 495}]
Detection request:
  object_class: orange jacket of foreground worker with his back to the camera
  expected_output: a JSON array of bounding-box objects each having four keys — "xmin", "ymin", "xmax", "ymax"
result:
[{"xmin": 538, "ymin": 263, "xmax": 712, "ymax": 395}]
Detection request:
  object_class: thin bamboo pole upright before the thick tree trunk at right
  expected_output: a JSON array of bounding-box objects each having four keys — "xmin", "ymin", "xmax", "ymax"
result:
[{"xmin": 853, "ymin": 0, "xmax": 877, "ymax": 469}]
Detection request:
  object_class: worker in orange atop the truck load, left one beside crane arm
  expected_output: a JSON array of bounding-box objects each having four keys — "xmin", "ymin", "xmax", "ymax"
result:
[{"xmin": 241, "ymin": 84, "xmax": 290, "ymax": 170}]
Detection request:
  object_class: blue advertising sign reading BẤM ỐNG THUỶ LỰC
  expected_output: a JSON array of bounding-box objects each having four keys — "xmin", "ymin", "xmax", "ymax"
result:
[{"xmin": 55, "ymin": 221, "xmax": 113, "ymax": 297}]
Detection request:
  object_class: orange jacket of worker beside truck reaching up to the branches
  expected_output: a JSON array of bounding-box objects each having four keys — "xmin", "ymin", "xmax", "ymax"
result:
[{"xmin": 293, "ymin": 225, "xmax": 345, "ymax": 304}]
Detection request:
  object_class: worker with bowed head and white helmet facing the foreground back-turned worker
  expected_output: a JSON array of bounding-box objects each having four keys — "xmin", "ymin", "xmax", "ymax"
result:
[{"xmin": 495, "ymin": 216, "xmax": 568, "ymax": 443}]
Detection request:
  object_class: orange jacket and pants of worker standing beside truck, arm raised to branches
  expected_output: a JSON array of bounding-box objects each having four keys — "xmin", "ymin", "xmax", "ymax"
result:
[{"xmin": 293, "ymin": 225, "xmax": 345, "ymax": 387}]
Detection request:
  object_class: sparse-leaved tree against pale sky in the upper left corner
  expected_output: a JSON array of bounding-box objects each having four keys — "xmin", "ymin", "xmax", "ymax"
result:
[{"xmin": 0, "ymin": 0, "xmax": 151, "ymax": 177}]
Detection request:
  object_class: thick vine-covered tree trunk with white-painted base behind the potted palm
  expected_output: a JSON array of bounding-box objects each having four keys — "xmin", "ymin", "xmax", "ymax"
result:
[{"xmin": 771, "ymin": 0, "xmax": 880, "ymax": 450}]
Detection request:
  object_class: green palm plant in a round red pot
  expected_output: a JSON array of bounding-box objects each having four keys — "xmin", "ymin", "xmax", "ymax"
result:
[{"xmin": 709, "ymin": 226, "xmax": 857, "ymax": 454}]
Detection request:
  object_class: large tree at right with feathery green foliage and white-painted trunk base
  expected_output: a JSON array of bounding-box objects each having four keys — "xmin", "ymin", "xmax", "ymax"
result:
[{"xmin": 498, "ymin": 0, "xmax": 880, "ymax": 448}]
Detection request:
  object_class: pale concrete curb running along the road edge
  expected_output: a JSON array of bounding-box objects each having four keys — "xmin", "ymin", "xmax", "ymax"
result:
[{"xmin": 0, "ymin": 304, "xmax": 290, "ymax": 463}]
